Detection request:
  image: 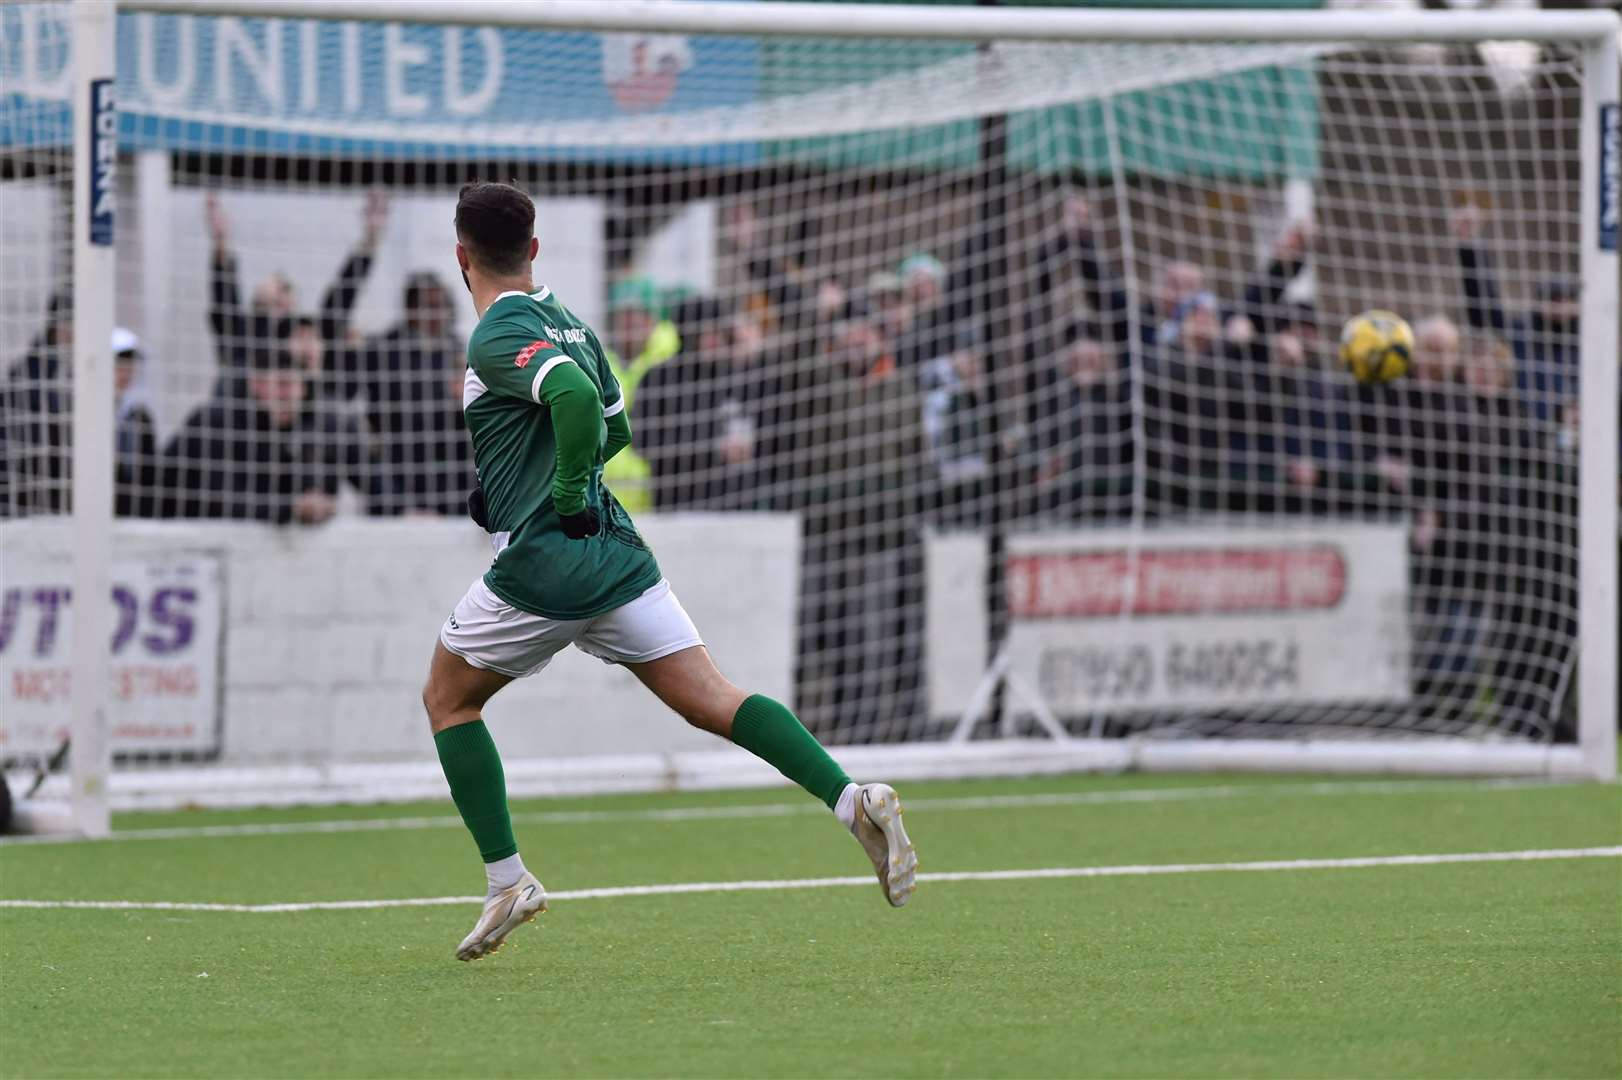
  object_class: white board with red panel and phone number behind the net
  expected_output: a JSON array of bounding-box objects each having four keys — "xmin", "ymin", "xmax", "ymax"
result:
[{"xmin": 929, "ymin": 524, "xmax": 1410, "ymax": 715}]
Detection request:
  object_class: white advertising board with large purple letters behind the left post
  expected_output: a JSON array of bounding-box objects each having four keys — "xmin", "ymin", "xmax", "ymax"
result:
[{"xmin": 0, "ymin": 550, "xmax": 225, "ymax": 761}]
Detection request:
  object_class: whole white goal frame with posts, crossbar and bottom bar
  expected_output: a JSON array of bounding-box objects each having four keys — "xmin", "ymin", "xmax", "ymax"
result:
[{"xmin": 38, "ymin": 0, "xmax": 1622, "ymax": 834}]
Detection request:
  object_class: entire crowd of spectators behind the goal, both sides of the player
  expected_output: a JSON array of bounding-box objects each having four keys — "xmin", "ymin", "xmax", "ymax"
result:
[{"xmin": 0, "ymin": 191, "xmax": 1581, "ymax": 736}]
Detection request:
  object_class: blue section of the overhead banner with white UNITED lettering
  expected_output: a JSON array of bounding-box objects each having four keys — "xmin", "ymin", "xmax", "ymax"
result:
[{"xmin": 0, "ymin": 5, "xmax": 759, "ymax": 162}]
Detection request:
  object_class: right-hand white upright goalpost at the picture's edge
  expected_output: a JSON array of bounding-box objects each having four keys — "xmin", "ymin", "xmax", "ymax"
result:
[{"xmin": 1577, "ymin": 34, "xmax": 1622, "ymax": 780}]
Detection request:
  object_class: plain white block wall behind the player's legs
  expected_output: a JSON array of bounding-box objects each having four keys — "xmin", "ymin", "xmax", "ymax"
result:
[{"xmin": 0, "ymin": 514, "xmax": 800, "ymax": 767}]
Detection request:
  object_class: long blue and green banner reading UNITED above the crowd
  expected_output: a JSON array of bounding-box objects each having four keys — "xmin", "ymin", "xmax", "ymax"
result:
[{"xmin": 0, "ymin": 7, "xmax": 1322, "ymax": 180}]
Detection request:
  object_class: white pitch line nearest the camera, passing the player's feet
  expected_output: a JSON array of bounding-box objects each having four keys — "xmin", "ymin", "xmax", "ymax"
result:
[{"xmin": 0, "ymin": 846, "xmax": 1622, "ymax": 915}]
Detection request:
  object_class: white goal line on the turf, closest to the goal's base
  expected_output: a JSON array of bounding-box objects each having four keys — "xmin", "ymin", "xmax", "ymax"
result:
[{"xmin": 0, "ymin": 778, "xmax": 1567, "ymax": 846}]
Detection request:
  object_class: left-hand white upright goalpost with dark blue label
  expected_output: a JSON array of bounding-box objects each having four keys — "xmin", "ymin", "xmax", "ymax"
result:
[{"xmin": 70, "ymin": 0, "xmax": 118, "ymax": 837}]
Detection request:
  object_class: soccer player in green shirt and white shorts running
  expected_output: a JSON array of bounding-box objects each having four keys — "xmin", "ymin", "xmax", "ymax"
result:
[{"xmin": 422, "ymin": 183, "xmax": 918, "ymax": 960}]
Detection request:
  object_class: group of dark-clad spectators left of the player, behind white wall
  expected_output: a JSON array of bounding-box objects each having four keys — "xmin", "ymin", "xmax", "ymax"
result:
[{"xmin": 0, "ymin": 195, "xmax": 472, "ymax": 525}]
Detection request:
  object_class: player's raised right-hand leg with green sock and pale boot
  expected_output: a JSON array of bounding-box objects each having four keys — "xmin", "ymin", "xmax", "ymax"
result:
[{"xmin": 626, "ymin": 635, "xmax": 918, "ymax": 908}]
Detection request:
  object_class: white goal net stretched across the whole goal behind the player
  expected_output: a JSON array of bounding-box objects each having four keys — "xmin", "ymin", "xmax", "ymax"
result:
[{"xmin": 0, "ymin": 3, "xmax": 1617, "ymax": 817}]
